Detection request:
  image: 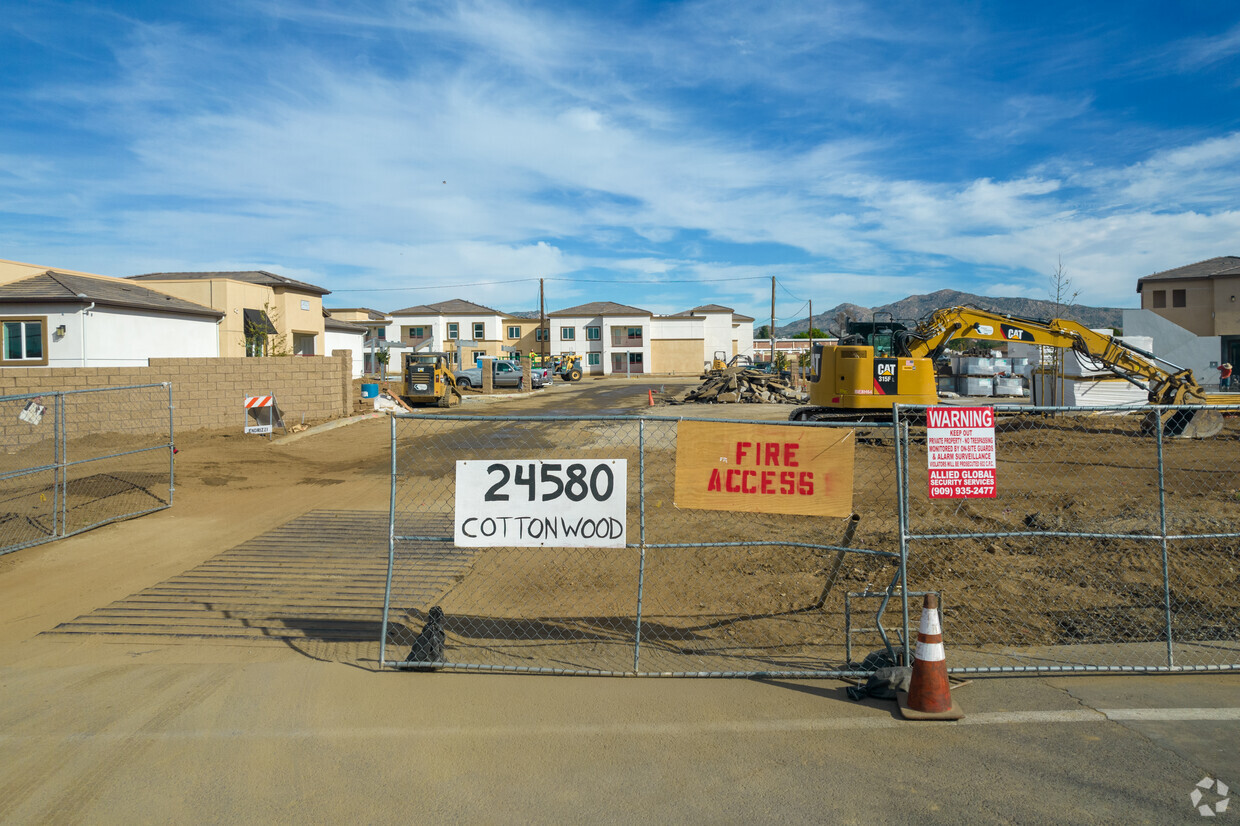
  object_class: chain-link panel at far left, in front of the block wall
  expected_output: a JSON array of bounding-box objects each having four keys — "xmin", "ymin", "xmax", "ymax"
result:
[{"xmin": 0, "ymin": 383, "xmax": 172, "ymax": 554}]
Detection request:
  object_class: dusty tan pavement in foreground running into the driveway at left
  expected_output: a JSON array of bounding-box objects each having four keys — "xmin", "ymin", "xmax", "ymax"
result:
[{"xmin": 0, "ymin": 382, "xmax": 1240, "ymax": 824}]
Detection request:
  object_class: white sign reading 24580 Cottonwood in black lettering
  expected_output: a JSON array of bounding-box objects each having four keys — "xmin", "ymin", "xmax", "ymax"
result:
[{"xmin": 454, "ymin": 459, "xmax": 629, "ymax": 548}]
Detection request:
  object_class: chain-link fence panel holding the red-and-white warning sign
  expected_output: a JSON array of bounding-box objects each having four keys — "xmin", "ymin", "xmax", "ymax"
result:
[{"xmin": 895, "ymin": 406, "xmax": 1240, "ymax": 673}]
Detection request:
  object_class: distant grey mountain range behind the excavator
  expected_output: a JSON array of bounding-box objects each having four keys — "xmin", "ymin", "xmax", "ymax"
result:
[{"xmin": 754, "ymin": 290, "xmax": 1123, "ymax": 339}]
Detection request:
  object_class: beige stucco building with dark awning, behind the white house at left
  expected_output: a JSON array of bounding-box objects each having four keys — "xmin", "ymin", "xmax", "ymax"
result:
[{"xmin": 129, "ymin": 270, "xmax": 329, "ymax": 357}]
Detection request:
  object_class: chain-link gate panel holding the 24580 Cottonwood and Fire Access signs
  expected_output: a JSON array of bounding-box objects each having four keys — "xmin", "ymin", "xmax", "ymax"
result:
[{"xmin": 381, "ymin": 415, "xmax": 899, "ymax": 677}]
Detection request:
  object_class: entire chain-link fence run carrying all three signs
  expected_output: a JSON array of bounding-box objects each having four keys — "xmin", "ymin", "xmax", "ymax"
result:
[{"xmin": 382, "ymin": 406, "xmax": 1240, "ymax": 676}]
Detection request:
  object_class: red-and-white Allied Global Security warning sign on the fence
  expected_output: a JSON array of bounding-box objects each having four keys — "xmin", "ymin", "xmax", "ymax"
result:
[{"xmin": 926, "ymin": 407, "xmax": 994, "ymax": 499}]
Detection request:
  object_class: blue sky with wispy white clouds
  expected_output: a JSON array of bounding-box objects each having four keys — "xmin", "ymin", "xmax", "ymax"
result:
[{"xmin": 0, "ymin": 0, "xmax": 1240, "ymax": 324}]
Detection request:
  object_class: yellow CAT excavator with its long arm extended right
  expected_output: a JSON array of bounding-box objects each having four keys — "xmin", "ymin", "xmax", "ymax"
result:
[{"xmin": 789, "ymin": 306, "xmax": 1235, "ymax": 439}]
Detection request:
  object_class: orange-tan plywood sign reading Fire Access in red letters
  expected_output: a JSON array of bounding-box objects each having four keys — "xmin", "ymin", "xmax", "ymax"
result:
[{"xmin": 676, "ymin": 422, "xmax": 853, "ymax": 516}]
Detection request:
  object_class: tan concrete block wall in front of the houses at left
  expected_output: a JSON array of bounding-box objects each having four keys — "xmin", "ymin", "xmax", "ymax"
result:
[{"xmin": 0, "ymin": 350, "xmax": 355, "ymax": 432}]
